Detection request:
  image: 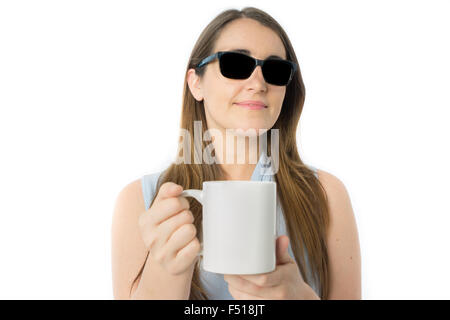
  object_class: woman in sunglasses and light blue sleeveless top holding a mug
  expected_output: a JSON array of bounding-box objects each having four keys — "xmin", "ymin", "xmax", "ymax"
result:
[{"xmin": 112, "ymin": 8, "xmax": 361, "ymax": 299}]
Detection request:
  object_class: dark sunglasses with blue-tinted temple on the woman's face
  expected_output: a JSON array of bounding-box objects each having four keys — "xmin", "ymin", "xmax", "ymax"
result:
[{"xmin": 197, "ymin": 51, "xmax": 297, "ymax": 86}]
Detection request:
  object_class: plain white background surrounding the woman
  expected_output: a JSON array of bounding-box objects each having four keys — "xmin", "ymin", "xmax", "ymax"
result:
[{"xmin": 0, "ymin": 0, "xmax": 450, "ymax": 299}]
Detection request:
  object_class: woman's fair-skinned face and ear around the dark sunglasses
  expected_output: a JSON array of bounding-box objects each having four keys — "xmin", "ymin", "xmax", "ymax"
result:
[{"xmin": 188, "ymin": 18, "xmax": 286, "ymax": 134}]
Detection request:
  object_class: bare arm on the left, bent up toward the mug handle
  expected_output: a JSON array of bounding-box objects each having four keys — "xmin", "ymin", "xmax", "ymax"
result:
[{"xmin": 111, "ymin": 180, "xmax": 192, "ymax": 299}]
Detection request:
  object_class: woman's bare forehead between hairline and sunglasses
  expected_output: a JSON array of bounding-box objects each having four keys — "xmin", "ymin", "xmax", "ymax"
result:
[{"xmin": 214, "ymin": 18, "xmax": 286, "ymax": 59}]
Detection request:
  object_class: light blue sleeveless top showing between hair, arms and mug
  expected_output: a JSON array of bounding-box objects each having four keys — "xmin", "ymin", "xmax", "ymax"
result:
[{"xmin": 141, "ymin": 152, "xmax": 320, "ymax": 300}]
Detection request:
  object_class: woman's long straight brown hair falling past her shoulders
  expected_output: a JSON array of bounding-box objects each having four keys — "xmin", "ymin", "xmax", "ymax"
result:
[{"xmin": 135, "ymin": 7, "xmax": 329, "ymax": 300}]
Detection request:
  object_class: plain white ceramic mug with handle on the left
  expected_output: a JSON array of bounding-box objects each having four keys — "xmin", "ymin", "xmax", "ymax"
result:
[{"xmin": 181, "ymin": 180, "xmax": 277, "ymax": 274}]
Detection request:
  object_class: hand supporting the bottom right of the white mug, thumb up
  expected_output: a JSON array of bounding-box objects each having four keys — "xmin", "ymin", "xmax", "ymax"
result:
[{"xmin": 224, "ymin": 235, "xmax": 318, "ymax": 300}]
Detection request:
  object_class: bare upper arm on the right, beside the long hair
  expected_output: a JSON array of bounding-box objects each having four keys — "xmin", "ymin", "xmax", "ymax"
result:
[{"xmin": 318, "ymin": 170, "xmax": 361, "ymax": 300}]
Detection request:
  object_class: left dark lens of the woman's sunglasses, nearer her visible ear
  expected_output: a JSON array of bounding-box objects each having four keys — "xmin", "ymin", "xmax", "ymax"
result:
[{"xmin": 220, "ymin": 52, "xmax": 255, "ymax": 79}]
